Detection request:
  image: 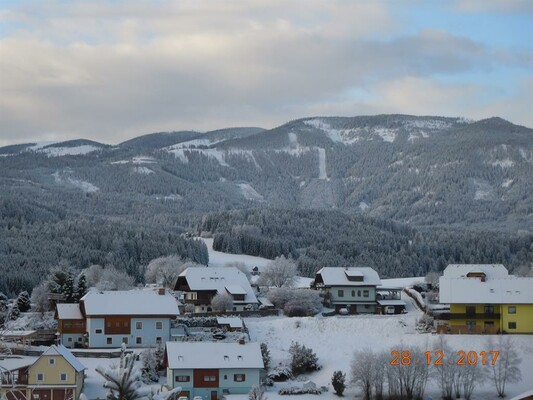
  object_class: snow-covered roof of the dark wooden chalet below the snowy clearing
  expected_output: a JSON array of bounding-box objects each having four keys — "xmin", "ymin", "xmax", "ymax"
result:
[{"xmin": 179, "ymin": 267, "xmax": 257, "ymax": 303}]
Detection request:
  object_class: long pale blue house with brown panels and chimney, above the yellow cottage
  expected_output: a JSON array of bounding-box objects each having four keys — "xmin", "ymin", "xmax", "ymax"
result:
[{"xmin": 56, "ymin": 289, "xmax": 179, "ymax": 348}]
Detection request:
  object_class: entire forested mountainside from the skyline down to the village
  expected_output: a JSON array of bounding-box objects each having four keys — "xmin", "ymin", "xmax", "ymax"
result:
[{"xmin": 0, "ymin": 115, "xmax": 533, "ymax": 294}]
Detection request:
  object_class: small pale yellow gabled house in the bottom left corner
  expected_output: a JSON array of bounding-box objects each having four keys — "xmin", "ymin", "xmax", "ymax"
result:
[{"xmin": 0, "ymin": 345, "xmax": 85, "ymax": 400}]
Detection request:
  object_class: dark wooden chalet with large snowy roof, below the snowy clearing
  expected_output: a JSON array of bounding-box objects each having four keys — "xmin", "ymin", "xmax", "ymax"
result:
[{"xmin": 174, "ymin": 267, "xmax": 258, "ymax": 313}]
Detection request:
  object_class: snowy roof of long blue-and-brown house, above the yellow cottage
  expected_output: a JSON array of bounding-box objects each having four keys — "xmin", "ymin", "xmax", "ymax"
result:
[{"xmin": 81, "ymin": 290, "xmax": 179, "ymax": 316}]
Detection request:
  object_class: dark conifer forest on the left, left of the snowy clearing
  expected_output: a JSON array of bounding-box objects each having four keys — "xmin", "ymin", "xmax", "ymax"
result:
[{"xmin": 0, "ymin": 201, "xmax": 209, "ymax": 296}]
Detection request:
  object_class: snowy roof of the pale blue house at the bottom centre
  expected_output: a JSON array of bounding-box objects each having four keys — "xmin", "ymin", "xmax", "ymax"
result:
[{"xmin": 166, "ymin": 342, "xmax": 264, "ymax": 369}]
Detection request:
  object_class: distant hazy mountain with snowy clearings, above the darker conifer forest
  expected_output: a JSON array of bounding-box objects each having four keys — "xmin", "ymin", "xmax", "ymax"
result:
[{"xmin": 0, "ymin": 115, "xmax": 533, "ymax": 230}]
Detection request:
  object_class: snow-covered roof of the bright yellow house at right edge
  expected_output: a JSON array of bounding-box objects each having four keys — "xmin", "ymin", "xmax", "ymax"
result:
[{"xmin": 439, "ymin": 264, "xmax": 533, "ymax": 304}]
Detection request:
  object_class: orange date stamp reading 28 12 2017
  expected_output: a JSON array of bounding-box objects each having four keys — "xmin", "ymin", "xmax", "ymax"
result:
[{"xmin": 390, "ymin": 350, "xmax": 500, "ymax": 366}]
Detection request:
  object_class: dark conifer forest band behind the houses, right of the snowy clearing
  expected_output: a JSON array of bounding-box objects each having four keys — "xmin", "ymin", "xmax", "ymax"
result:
[{"xmin": 199, "ymin": 209, "xmax": 533, "ymax": 278}]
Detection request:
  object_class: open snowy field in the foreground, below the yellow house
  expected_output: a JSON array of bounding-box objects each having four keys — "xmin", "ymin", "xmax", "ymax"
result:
[{"xmin": 245, "ymin": 310, "xmax": 533, "ymax": 400}]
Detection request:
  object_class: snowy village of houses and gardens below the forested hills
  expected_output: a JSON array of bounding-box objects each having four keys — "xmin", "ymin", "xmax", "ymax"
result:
[{"xmin": 0, "ymin": 241, "xmax": 533, "ymax": 400}]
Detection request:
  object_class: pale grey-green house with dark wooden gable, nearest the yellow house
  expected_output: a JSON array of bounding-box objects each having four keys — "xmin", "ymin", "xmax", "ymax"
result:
[{"xmin": 311, "ymin": 267, "xmax": 381, "ymax": 314}]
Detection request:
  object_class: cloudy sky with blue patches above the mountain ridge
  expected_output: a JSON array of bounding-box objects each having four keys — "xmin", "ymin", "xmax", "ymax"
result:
[{"xmin": 0, "ymin": 0, "xmax": 533, "ymax": 146}]
